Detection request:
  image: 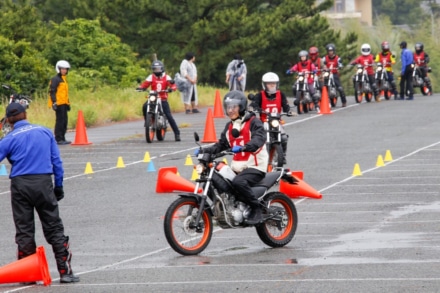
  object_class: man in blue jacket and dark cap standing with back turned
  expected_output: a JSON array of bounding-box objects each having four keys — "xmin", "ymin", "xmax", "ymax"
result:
[{"xmin": 0, "ymin": 103, "xmax": 79, "ymax": 283}]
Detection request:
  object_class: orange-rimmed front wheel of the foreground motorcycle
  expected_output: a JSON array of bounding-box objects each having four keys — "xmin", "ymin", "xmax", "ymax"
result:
[{"xmin": 164, "ymin": 197, "xmax": 213, "ymax": 255}]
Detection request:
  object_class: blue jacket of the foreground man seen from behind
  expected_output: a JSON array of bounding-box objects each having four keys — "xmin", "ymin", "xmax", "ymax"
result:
[{"xmin": 0, "ymin": 120, "xmax": 64, "ymax": 186}]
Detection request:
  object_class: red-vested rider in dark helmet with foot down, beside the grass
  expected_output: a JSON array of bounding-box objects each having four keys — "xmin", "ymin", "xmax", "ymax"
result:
[{"xmin": 137, "ymin": 61, "xmax": 180, "ymax": 141}]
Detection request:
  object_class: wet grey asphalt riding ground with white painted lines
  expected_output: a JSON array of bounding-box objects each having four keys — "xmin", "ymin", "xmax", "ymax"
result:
[{"xmin": 0, "ymin": 94, "xmax": 440, "ymax": 292}]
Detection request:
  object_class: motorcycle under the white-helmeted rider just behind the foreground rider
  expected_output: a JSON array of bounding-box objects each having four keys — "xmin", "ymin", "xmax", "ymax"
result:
[{"xmin": 248, "ymin": 94, "xmax": 290, "ymax": 172}]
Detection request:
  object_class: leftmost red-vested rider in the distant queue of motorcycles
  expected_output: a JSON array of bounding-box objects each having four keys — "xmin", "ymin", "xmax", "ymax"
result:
[{"xmin": 286, "ymin": 50, "xmax": 321, "ymax": 113}]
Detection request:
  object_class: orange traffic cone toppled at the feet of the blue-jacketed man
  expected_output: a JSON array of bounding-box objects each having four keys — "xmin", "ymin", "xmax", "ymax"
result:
[{"xmin": 0, "ymin": 246, "xmax": 52, "ymax": 286}]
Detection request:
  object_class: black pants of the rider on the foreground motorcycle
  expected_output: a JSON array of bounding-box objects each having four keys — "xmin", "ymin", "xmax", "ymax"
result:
[{"xmin": 232, "ymin": 168, "xmax": 265, "ymax": 208}]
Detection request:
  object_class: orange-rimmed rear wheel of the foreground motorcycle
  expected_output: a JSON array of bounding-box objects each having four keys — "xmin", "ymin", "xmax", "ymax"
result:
[{"xmin": 255, "ymin": 192, "xmax": 298, "ymax": 247}]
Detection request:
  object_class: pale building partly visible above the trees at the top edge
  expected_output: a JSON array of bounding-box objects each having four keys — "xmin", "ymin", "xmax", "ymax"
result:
[{"xmin": 317, "ymin": 0, "xmax": 373, "ymax": 26}]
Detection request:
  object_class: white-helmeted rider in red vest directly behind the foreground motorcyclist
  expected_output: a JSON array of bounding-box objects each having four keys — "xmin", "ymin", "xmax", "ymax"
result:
[{"xmin": 250, "ymin": 72, "xmax": 296, "ymax": 164}]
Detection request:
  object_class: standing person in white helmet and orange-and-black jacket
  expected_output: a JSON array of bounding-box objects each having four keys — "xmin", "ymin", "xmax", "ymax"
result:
[{"xmin": 48, "ymin": 60, "xmax": 70, "ymax": 145}]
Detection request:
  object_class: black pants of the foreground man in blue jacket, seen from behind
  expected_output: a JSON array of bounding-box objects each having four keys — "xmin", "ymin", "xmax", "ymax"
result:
[{"xmin": 11, "ymin": 175, "xmax": 71, "ymax": 273}]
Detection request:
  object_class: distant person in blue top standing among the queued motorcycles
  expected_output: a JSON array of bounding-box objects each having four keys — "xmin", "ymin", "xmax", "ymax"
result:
[{"xmin": 399, "ymin": 41, "xmax": 414, "ymax": 100}]
